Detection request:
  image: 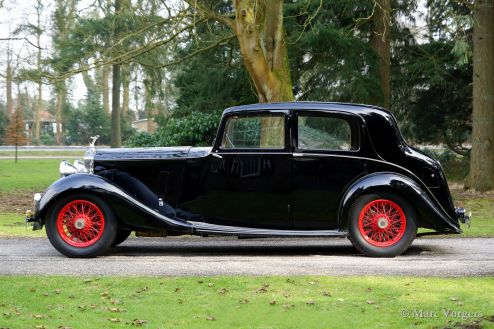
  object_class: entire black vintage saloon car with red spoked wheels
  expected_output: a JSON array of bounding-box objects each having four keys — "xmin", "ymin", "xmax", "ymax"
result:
[{"xmin": 26, "ymin": 102, "xmax": 469, "ymax": 257}]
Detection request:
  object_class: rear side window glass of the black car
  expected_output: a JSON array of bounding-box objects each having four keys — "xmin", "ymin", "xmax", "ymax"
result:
[{"xmin": 298, "ymin": 114, "xmax": 359, "ymax": 151}]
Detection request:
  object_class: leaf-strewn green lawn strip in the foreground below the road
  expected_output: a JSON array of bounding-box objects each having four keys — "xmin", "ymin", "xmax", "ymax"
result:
[{"xmin": 0, "ymin": 276, "xmax": 494, "ymax": 329}]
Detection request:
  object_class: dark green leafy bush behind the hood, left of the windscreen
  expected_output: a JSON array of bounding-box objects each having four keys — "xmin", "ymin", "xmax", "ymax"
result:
[{"xmin": 125, "ymin": 112, "xmax": 221, "ymax": 147}]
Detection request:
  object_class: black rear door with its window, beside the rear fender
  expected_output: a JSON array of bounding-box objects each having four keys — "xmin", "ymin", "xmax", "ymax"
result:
[{"xmin": 292, "ymin": 110, "xmax": 364, "ymax": 229}]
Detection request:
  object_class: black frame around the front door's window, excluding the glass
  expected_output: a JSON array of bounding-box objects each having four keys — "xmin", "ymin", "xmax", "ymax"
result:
[{"xmin": 214, "ymin": 110, "xmax": 290, "ymax": 153}]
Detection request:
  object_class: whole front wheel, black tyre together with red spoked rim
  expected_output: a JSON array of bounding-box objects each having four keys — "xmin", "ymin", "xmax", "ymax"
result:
[{"xmin": 45, "ymin": 192, "xmax": 118, "ymax": 258}]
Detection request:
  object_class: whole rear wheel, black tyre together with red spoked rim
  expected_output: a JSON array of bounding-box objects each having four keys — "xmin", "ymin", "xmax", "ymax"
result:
[{"xmin": 348, "ymin": 193, "xmax": 417, "ymax": 257}]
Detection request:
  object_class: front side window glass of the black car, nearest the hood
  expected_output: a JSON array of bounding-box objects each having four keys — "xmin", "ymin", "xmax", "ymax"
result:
[{"xmin": 221, "ymin": 114, "xmax": 285, "ymax": 149}]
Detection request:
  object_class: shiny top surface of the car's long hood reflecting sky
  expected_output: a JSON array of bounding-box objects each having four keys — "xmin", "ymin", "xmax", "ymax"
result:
[{"xmin": 94, "ymin": 146, "xmax": 211, "ymax": 161}]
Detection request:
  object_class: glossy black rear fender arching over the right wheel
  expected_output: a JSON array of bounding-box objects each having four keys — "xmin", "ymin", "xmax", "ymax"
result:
[{"xmin": 339, "ymin": 172, "xmax": 462, "ymax": 233}]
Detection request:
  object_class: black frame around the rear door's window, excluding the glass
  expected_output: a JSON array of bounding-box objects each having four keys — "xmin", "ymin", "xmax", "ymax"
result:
[{"xmin": 293, "ymin": 110, "xmax": 363, "ymax": 155}]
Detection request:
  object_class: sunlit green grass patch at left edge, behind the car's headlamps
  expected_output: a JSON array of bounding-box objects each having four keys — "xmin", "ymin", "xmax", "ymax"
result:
[{"xmin": 0, "ymin": 157, "xmax": 63, "ymax": 191}]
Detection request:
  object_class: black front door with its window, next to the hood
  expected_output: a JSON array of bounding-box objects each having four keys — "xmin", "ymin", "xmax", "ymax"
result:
[{"xmin": 197, "ymin": 111, "xmax": 291, "ymax": 229}]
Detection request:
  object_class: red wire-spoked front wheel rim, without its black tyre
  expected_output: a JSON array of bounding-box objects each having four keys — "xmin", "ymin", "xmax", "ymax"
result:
[{"xmin": 57, "ymin": 200, "xmax": 105, "ymax": 248}]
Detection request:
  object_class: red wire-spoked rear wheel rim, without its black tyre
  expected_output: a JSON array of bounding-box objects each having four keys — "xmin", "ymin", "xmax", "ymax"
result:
[{"xmin": 358, "ymin": 199, "xmax": 407, "ymax": 247}]
